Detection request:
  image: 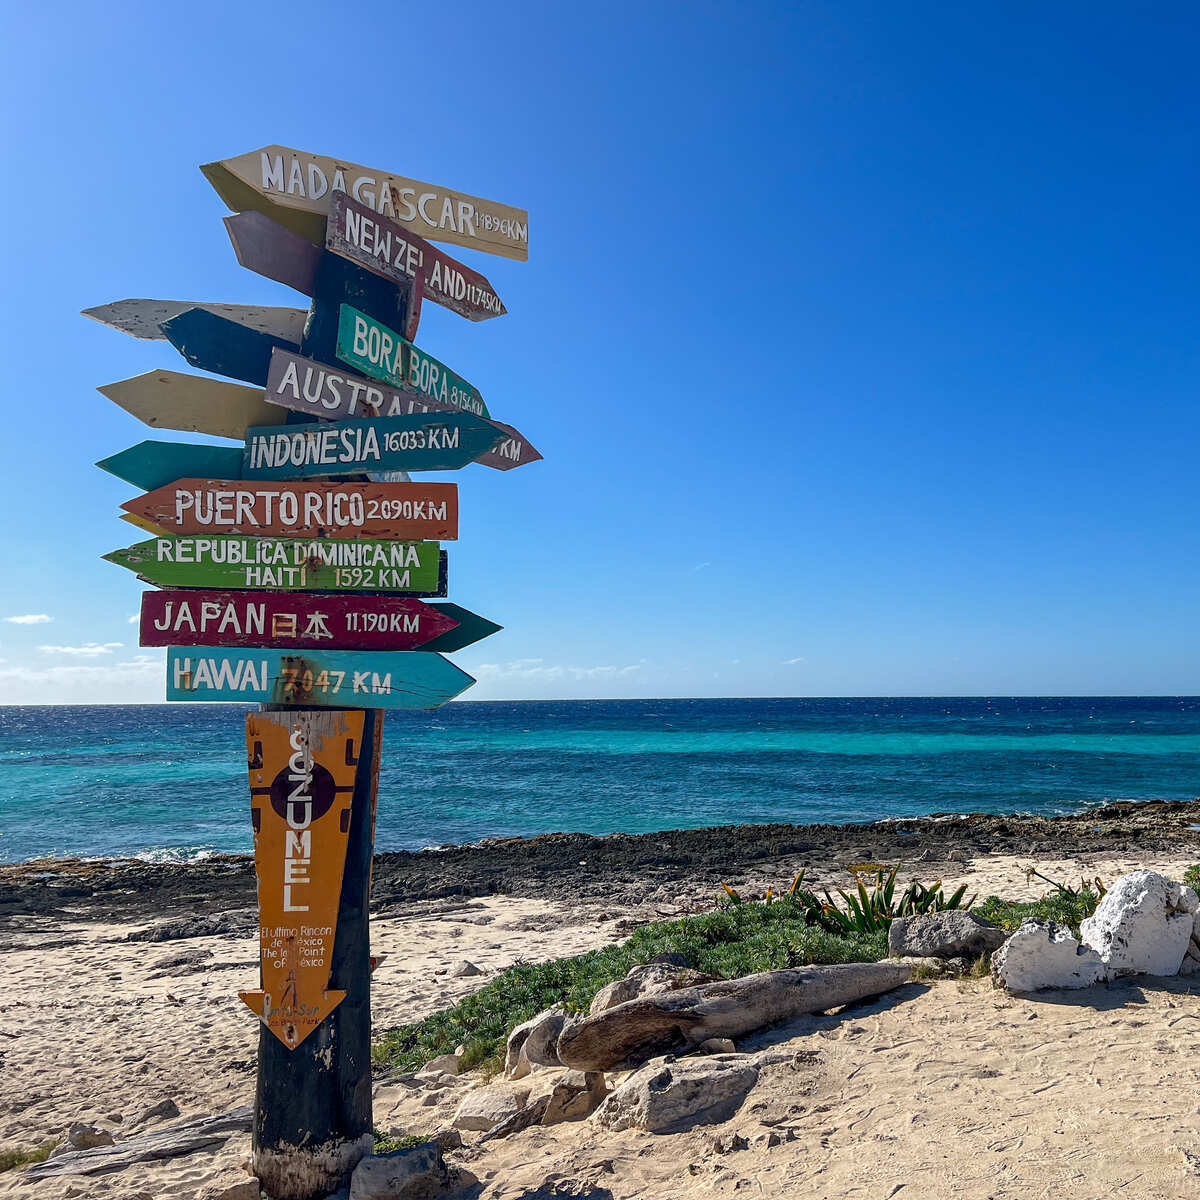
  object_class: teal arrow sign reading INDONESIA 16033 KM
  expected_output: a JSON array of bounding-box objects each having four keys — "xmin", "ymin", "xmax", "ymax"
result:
[{"xmin": 241, "ymin": 413, "xmax": 503, "ymax": 479}]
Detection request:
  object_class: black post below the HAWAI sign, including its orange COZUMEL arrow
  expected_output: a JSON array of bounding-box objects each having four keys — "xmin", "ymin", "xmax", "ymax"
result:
[{"xmin": 244, "ymin": 708, "xmax": 383, "ymax": 1200}]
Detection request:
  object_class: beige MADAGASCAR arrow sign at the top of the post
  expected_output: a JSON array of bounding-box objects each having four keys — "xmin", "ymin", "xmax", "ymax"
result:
[{"xmin": 200, "ymin": 146, "xmax": 529, "ymax": 262}]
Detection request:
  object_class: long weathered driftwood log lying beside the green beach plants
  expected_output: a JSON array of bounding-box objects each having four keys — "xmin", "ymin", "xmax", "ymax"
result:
[{"xmin": 558, "ymin": 962, "xmax": 912, "ymax": 1070}]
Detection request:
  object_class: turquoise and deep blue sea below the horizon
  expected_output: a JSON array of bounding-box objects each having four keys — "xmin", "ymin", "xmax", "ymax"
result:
[{"xmin": 0, "ymin": 697, "xmax": 1200, "ymax": 862}]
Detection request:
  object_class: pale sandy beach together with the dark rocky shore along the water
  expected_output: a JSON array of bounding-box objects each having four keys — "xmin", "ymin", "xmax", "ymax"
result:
[{"xmin": 7, "ymin": 805, "xmax": 1200, "ymax": 1200}]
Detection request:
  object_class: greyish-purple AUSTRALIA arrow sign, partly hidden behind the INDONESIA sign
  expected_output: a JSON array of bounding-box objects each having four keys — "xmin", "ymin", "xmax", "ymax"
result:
[{"xmin": 266, "ymin": 350, "xmax": 541, "ymax": 470}]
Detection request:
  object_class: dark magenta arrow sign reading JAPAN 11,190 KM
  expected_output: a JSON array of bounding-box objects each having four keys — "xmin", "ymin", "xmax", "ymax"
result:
[{"xmin": 140, "ymin": 589, "xmax": 458, "ymax": 650}]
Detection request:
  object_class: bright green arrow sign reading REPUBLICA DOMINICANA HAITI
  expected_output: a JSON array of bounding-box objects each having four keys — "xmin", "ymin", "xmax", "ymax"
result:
[{"xmin": 104, "ymin": 536, "xmax": 448, "ymax": 595}]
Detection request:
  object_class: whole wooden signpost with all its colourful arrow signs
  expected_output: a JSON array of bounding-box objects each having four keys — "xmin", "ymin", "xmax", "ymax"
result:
[{"xmin": 93, "ymin": 146, "xmax": 541, "ymax": 1200}]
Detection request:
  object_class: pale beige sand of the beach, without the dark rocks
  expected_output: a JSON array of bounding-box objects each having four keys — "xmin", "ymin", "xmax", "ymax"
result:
[{"xmin": 0, "ymin": 856, "xmax": 1200, "ymax": 1200}]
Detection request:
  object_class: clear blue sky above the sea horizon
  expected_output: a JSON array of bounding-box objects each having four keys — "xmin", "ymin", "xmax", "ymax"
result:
[{"xmin": 0, "ymin": 2, "xmax": 1200, "ymax": 702}]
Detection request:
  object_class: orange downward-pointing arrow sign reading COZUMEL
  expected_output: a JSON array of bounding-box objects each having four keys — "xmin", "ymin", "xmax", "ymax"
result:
[{"xmin": 239, "ymin": 709, "xmax": 364, "ymax": 1050}]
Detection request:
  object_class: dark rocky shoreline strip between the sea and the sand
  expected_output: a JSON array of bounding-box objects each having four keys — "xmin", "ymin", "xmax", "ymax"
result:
[{"xmin": 0, "ymin": 800, "xmax": 1200, "ymax": 932}]
